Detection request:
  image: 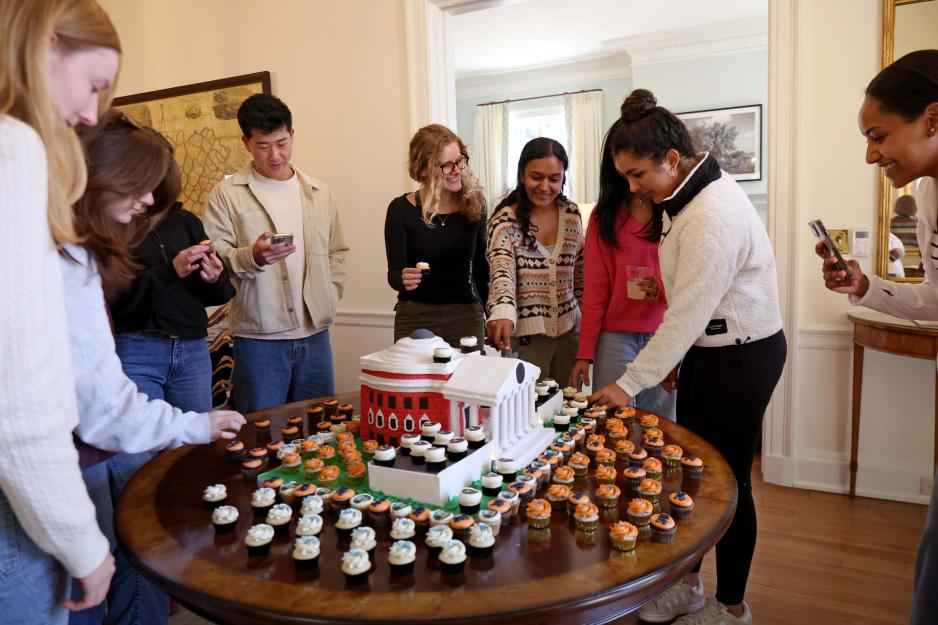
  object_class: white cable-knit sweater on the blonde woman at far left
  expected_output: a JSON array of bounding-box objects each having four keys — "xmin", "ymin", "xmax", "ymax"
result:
[{"xmin": 0, "ymin": 115, "xmax": 109, "ymax": 577}]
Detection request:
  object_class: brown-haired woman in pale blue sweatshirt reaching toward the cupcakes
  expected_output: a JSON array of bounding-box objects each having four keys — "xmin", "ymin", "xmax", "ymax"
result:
[{"xmin": 68, "ymin": 110, "xmax": 245, "ymax": 625}]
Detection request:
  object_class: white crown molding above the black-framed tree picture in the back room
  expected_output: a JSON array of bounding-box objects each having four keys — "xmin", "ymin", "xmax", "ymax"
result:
[{"xmin": 601, "ymin": 19, "xmax": 769, "ymax": 67}]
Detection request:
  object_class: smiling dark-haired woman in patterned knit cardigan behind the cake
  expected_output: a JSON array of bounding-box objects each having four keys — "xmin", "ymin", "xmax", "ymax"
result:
[{"xmin": 486, "ymin": 137, "xmax": 584, "ymax": 381}]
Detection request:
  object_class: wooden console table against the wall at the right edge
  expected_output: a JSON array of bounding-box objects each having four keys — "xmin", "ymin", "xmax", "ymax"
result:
[{"xmin": 847, "ymin": 312, "xmax": 938, "ymax": 497}]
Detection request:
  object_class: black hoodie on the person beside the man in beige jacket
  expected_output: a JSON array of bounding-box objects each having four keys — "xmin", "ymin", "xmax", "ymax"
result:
[{"xmin": 108, "ymin": 202, "xmax": 235, "ymax": 339}]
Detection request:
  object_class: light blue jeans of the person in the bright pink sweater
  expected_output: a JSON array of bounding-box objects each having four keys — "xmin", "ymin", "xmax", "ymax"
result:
[{"xmin": 593, "ymin": 332, "xmax": 677, "ymax": 421}]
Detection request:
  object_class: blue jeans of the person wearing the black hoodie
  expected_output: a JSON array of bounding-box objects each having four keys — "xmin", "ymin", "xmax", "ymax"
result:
[{"xmin": 116, "ymin": 332, "xmax": 212, "ymax": 412}]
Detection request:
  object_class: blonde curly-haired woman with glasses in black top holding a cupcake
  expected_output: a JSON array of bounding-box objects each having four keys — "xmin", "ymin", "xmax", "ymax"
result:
[{"xmin": 384, "ymin": 124, "xmax": 489, "ymax": 347}]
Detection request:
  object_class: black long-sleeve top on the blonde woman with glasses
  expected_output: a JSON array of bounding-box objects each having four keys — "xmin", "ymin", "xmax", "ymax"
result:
[{"xmin": 384, "ymin": 194, "xmax": 489, "ymax": 304}]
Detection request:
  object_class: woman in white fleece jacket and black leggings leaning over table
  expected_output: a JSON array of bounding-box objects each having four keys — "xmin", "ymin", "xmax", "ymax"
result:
[{"xmin": 591, "ymin": 89, "xmax": 787, "ymax": 625}]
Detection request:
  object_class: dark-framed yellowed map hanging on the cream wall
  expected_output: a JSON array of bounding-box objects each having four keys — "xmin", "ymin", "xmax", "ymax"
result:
[{"xmin": 114, "ymin": 72, "xmax": 270, "ymax": 215}]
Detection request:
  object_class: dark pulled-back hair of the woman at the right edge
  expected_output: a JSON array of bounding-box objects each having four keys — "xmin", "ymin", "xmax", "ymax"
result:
[{"xmin": 866, "ymin": 50, "xmax": 938, "ymax": 122}]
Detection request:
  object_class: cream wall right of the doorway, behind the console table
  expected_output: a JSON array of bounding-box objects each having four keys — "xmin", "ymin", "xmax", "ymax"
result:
[{"xmin": 790, "ymin": 0, "xmax": 935, "ymax": 501}]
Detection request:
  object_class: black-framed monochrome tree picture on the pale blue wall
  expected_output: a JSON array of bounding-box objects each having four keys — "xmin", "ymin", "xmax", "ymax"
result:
[{"xmin": 677, "ymin": 104, "xmax": 762, "ymax": 180}]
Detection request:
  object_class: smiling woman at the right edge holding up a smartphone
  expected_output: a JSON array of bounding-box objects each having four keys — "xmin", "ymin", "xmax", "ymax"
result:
[{"xmin": 816, "ymin": 50, "xmax": 938, "ymax": 625}]
